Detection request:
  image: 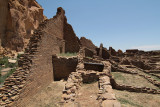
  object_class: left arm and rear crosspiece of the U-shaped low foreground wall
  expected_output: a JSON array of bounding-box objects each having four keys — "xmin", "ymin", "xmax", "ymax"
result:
[{"xmin": 62, "ymin": 70, "xmax": 104, "ymax": 103}]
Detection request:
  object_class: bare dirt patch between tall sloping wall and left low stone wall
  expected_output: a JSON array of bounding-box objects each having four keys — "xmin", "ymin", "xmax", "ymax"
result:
[{"xmin": 26, "ymin": 81, "xmax": 65, "ymax": 107}]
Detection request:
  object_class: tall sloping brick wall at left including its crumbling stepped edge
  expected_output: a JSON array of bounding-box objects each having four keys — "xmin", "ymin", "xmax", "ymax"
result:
[{"xmin": 0, "ymin": 7, "xmax": 71, "ymax": 107}]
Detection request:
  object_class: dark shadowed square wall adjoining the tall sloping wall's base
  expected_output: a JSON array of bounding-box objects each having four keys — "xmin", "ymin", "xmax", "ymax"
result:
[{"xmin": 52, "ymin": 55, "xmax": 78, "ymax": 80}]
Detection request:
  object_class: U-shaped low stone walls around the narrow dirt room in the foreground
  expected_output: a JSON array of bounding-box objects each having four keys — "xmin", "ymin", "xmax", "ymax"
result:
[{"xmin": 62, "ymin": 61, "xmax": 121, "ymax": 107}]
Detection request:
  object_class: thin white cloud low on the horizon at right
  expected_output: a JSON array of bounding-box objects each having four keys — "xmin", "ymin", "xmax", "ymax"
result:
[{"xmin": 132, "ymin": 45, "xmax": 160, "ymax": 51}]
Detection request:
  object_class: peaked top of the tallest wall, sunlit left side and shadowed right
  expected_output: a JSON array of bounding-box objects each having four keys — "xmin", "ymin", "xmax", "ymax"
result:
[{"xmin": 45, "ymin": 7, "xmax": 80, "ymax": 53}]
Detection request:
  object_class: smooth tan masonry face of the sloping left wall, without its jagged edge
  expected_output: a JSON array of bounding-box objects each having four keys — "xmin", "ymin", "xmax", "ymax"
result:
[{"xmin": 15, "ymin": 32, "xmax": 59, "ymax": 107}]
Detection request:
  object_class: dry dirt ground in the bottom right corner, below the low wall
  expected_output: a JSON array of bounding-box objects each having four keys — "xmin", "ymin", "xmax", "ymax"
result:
[{"xmin": 114, "ymin": 90, "xmax": 160, "ymax": 107}]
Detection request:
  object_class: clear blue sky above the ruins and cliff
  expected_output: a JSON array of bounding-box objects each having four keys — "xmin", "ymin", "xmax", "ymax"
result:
[{"xmin": 37, "ymin": 0, "xmax": 160, "ymax": 51}]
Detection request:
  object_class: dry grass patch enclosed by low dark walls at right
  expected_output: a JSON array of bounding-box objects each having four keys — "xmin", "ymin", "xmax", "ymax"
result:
[{"xmin": 112, "ymin": 72, "xmax": 159, "ymax": 89}]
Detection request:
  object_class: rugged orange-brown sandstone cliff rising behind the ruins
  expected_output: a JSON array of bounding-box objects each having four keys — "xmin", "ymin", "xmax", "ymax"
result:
[{"xmin": 0, "ymin": 0, "xmax": 46, "ymax": 51}]
